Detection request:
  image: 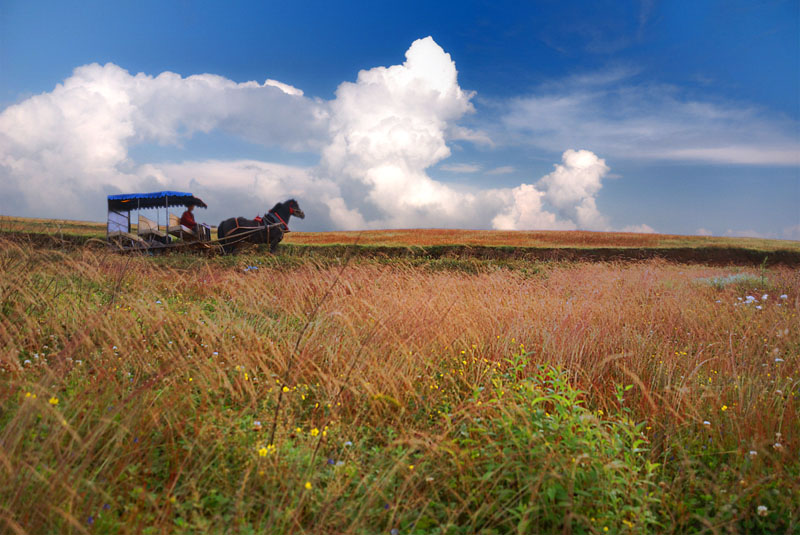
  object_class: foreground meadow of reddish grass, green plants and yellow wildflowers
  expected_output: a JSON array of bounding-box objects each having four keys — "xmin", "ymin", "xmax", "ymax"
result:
[{"xmin": 0, "ymin": 231, "xmax": 800, "ymax": 535}]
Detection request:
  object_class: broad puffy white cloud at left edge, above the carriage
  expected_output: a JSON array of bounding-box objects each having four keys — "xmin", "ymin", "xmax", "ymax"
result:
[{"xmin": 0, "ymin": 64, "xmax": 327, "ymax": 218}]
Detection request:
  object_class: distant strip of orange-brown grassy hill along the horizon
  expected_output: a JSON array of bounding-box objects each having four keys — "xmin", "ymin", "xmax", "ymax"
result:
[{"xmin": 0, "ymin": 217, "xmax": 800, "ymax": 266}]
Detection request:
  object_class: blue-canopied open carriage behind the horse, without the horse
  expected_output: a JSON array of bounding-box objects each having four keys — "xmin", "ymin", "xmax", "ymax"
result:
[{"xmin": 106, "ymin": 191, "xmax": 211, "ymax": 251}]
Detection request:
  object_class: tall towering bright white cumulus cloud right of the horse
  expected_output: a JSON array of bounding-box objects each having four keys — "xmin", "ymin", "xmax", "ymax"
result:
[{"xmin": 321, "ymin": 37, "xmax": 482, "ymax": 226}]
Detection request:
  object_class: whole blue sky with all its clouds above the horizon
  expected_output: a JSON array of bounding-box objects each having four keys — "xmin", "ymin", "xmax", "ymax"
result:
[{"xmin": 0, "ymin": 0, "xmax": 800, "ymax": 240}]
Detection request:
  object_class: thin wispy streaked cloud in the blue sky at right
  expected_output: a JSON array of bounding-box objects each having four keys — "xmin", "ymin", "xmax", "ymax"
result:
[{"xmin": 502, "ymin": 68, "xmax": 800, "ymax": 166}]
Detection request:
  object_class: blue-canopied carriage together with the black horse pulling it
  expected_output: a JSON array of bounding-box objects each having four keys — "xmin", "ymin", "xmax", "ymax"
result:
[{"xmin": 106, "ymin": 191, "xmax": 305, "ymax": 253}]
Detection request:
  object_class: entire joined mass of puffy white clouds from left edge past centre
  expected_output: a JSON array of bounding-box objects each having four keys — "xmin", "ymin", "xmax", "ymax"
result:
[{"xmin": 0, "ymin": 37, "xmax": 649, "ymax": 230}]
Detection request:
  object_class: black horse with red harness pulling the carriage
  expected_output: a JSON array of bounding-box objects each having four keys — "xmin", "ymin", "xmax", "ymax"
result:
[{"xmin": 217, "ymin": 199, "xmax": 306, "ymax": 254}]
